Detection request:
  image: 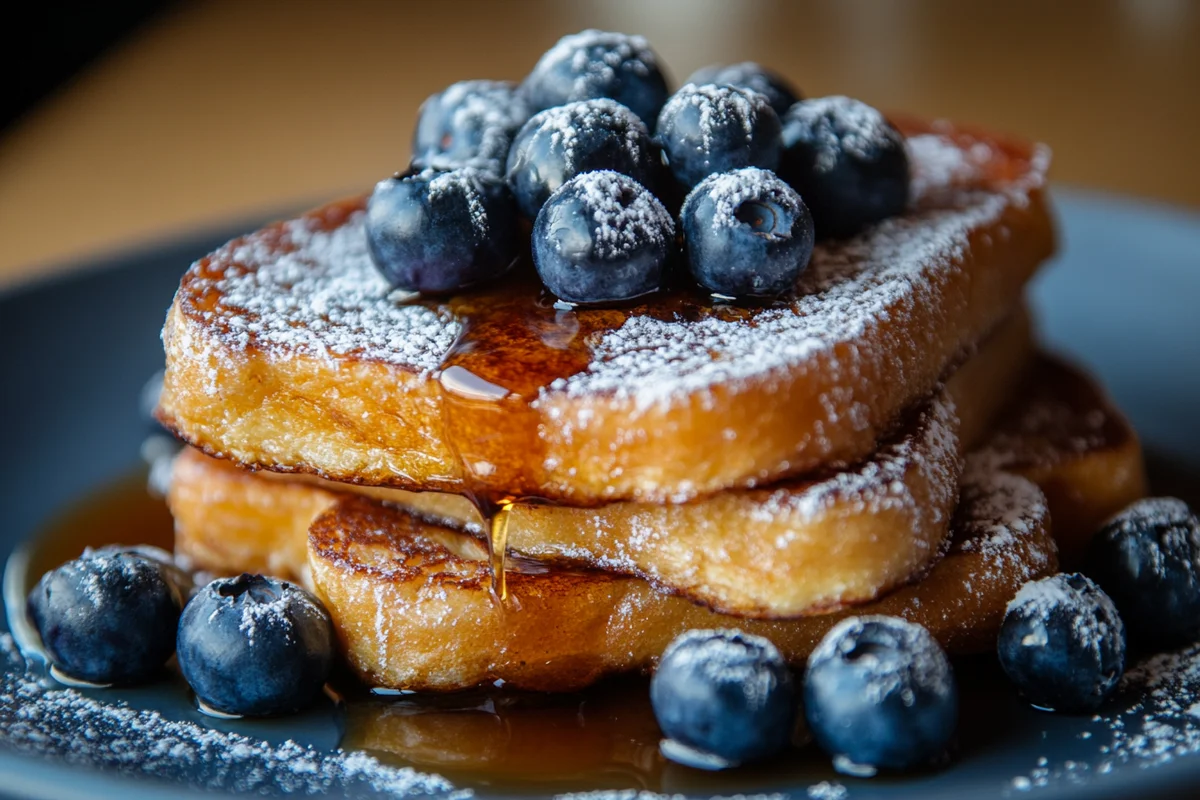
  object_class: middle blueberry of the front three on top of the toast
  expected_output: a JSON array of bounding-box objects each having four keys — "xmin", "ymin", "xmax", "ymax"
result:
[{"xmin": 533, "ymin": 170, "xmax": 674, "ymax": 303}]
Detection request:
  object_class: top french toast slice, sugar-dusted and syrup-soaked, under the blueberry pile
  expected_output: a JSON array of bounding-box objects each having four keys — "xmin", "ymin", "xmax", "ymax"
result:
[{"xmin": 158, "ymin": 122, "xmax": 1054, "ymax": 506}]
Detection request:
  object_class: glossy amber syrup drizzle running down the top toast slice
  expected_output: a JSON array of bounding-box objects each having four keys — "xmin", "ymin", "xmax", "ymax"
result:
[{"xmin": 429, "ymin": 268, "xmax": 754, "ymax": 600}]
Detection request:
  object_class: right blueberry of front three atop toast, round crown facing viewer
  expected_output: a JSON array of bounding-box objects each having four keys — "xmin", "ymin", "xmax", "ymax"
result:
[{"xmin": 680, "ymin": 167, "xmax": 812, "ymax": 297}]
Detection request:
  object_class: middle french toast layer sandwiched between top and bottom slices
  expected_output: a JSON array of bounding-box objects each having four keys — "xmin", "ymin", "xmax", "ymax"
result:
[{"xmin": 168, "ymin": 308, "xmax": 1032, "ymax": 616}]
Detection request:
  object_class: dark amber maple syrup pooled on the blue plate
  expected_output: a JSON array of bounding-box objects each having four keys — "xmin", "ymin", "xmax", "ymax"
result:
[{"xmin": 9, "ymin": 473, "xmax": 832, "ymax": 794}]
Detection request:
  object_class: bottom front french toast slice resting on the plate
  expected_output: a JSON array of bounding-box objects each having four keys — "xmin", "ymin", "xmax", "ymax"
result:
[{"xmin": 308, "ymin": 473, "xmax": 1057, "ymax": 691}]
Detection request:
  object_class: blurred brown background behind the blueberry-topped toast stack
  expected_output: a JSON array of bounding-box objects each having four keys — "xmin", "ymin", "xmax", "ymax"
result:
[{"xmin": 0, "ymin": 0, "xmax": 1200, "ymax": 287}]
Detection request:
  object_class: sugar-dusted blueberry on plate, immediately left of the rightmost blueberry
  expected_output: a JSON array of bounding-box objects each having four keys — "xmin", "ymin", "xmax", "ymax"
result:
[{"xmin": 996, "ymin": 573, "xmax": 1126, "ymax": 711}]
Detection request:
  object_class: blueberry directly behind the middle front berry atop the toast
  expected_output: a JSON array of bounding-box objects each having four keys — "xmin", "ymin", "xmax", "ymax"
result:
[{"xmin": 508, "ymin": 98, "xmax": 656, "ymax": 219}]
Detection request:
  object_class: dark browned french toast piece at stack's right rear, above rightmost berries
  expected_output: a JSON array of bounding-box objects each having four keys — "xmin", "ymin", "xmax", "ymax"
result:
[{"xmin": 968, "ymin": 355, "xmax": 1147, "ymax": 566}]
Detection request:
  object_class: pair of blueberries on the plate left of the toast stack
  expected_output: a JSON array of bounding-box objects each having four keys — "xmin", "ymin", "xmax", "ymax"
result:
[{"xmin": 26, "ymin": 547, "xmax": 335, "ymax": 716}]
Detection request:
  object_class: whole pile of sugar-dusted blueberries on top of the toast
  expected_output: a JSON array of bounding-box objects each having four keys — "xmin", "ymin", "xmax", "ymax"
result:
[{"xmin": 366, "ymin": 30, "xmax": 908, "ymax": 303}]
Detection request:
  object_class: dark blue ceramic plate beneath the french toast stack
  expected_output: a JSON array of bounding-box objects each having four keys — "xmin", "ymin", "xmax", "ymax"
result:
[{"xmin": 0, "ymin": 191, "xmax": 1200, "ymax": 800}]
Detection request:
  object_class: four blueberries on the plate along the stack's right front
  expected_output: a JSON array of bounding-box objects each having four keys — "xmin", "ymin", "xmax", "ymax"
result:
[{"xmin": 650, "ymin": 498, "xmax": 1200, "ymax": 776}]
